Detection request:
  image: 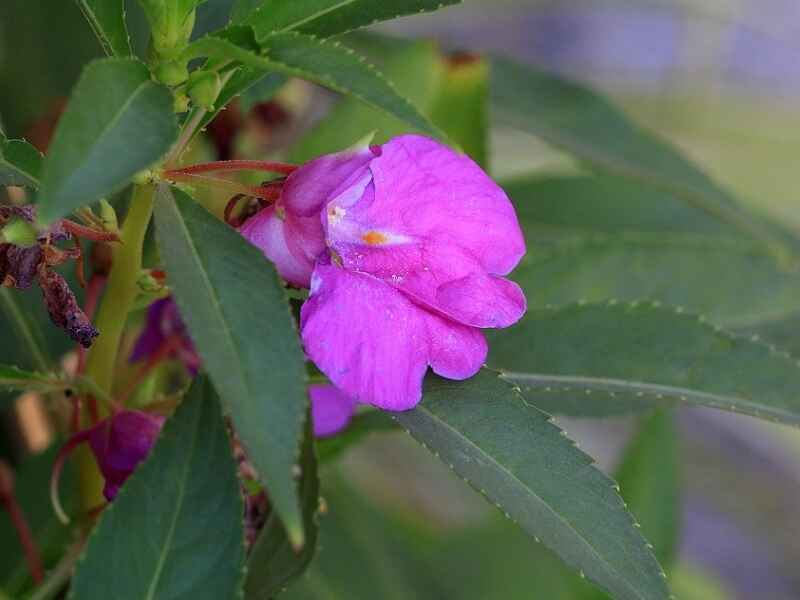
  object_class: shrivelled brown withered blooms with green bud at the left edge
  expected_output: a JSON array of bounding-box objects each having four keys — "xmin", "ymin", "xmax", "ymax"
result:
[{"xmin": 0, "ymin": 206, "xmax": 99, "ymax": 348}]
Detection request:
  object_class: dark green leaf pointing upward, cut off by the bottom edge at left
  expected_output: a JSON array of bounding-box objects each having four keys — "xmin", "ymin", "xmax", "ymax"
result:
[{"xmin": 68, "ymin": 378, "xmax": 244, "ymax": 600}]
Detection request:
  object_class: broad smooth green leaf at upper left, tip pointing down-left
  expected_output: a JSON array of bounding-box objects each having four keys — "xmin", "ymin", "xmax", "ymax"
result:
[{"xmin": 39, "ymin": 58, "xmax": 178, "ymax": 222}]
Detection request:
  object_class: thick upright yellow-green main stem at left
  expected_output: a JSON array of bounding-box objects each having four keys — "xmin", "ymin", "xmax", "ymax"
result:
[{"xmin": 77, "ymin": 185, "xmax": 155, "ymax": 510}]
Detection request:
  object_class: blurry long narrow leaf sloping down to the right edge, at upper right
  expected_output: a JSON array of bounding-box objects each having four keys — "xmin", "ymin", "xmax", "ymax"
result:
[{"xmin": 491, "ymin": 59, "xmax": 798, "ymax": 257}]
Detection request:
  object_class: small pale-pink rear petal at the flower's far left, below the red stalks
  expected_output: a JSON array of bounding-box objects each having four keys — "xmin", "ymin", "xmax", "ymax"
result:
[{"xmin": 239, "ymin": 206, "xmax": 322, "ymax": 287}]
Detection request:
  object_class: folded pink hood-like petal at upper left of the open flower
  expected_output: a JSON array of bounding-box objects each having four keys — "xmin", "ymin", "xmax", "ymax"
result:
[{"xmin": 281, "ymin": 148, "xmax": 375, "ymax": 217}]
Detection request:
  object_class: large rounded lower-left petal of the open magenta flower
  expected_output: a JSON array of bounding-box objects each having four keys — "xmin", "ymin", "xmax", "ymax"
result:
[{"xmin": 300, "ymin": 263, "xmax": 429, "ymax": 410}]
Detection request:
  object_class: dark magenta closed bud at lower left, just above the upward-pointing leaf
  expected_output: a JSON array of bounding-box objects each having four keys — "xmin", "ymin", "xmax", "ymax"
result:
[{"xmin": 88, "ymin": 410, "xmax": 164, "ymax": 502}]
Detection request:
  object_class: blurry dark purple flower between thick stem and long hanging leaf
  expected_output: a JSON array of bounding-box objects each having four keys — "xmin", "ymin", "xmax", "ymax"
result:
[{"xmin": 130, "ymin": 296, "xmax": 200, "ymax": 376}]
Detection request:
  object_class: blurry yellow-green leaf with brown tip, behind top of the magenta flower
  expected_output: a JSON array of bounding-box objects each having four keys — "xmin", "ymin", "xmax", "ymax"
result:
[{"xmin": 430, "ymin": 55, "xmax": 489, "ymax": 170}]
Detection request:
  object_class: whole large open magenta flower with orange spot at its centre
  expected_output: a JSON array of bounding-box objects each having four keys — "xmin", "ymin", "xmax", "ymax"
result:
[{"xmin": 241, "ymin": 135, "xmax": 526, "ymax": 410}]
